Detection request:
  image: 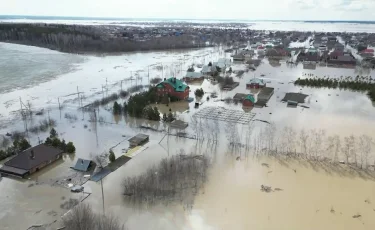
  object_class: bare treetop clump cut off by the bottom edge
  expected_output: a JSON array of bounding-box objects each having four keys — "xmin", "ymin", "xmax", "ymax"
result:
[{"xmin": 62, "ymin": 204, "xmax": 125, "ymax": 230}]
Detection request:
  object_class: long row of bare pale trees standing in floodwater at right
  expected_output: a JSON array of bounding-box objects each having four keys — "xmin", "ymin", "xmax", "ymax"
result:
[{"xmin": 225, "ymin": 122, "xmax": 375, "ymax": 170}]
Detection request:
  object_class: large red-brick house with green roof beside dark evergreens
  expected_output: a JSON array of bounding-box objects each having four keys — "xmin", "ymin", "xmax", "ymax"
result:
[{"xmin": 156, "ymin": 77, "xmax": 190, "ymax": 100}]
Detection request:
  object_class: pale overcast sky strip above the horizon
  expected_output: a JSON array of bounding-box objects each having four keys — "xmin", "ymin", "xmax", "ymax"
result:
[{"xmin": 0, "ymin": 0, "xmax": 375, "ymax": 20}]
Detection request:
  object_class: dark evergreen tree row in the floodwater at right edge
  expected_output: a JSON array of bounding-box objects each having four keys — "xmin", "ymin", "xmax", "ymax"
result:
[{"xmin": 294, "ymin": 78, "xmax": 375, "ymax": 101}]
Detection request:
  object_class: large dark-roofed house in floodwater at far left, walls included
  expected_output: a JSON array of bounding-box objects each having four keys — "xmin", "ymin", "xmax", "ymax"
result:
[{"xmin": 0, "ymin": 144, "xmax": 63, "ymax": 178}]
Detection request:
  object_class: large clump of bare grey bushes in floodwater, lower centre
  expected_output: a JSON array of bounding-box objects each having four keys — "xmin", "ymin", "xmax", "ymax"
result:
[{"xmin": 123, "ymin": 151, "xmax": 209, "ymax": 207}]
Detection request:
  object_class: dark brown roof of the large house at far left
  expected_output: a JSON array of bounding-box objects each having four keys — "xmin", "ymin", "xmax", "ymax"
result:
[{"xmin": 5, "ymin": 144, "xmax": 63, "ymax": 170}]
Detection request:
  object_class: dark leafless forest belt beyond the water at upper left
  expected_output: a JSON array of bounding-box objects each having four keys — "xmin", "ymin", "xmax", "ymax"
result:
[{"xmin": 0, "ymin": 23, "xmax": 206, "ymax": 53}]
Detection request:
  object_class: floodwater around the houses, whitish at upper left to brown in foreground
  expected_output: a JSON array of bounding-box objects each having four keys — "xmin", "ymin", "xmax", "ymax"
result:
[{"xmin": 0, "ymin": 41, "xmax": 375, "ymax": 230}]
